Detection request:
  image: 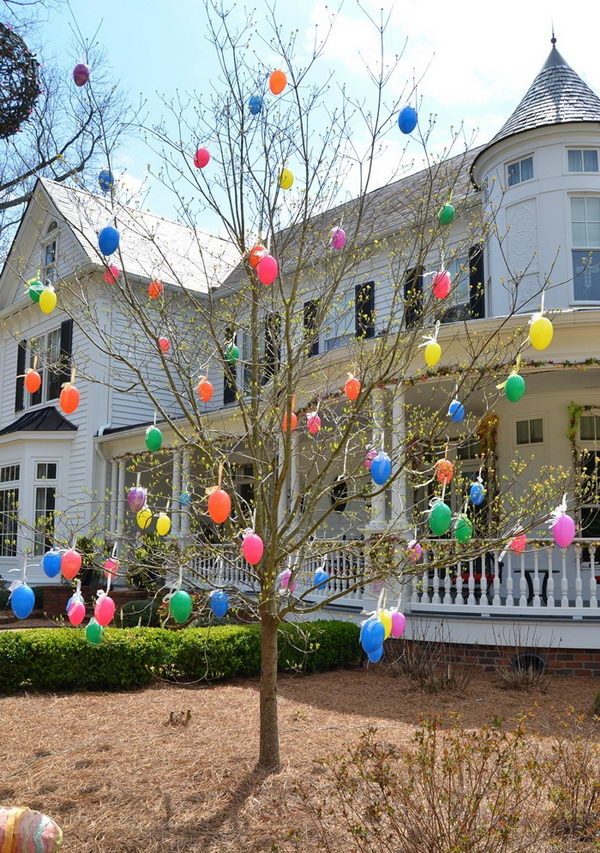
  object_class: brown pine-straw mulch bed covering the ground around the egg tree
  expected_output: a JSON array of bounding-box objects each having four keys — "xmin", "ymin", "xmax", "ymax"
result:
[{"xmin": 0, "ymin": 669, "xmax": 600, "ymax": 853}]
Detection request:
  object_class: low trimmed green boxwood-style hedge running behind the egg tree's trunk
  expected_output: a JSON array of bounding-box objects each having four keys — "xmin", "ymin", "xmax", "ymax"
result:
[{"xmin": 0, "ymin": 620, "xmax": 360, "ymax": 693}]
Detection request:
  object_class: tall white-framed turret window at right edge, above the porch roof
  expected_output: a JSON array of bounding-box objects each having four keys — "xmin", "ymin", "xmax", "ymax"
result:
[{"xmin": 571, "ymin": 196, "xmax": 600, "ymax": 302}]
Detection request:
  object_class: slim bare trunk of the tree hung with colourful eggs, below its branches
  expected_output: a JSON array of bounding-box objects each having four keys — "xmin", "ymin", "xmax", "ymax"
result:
[{"xmin": 258, "ymin": 612, "xmax": 279, "ymax": 771}]
